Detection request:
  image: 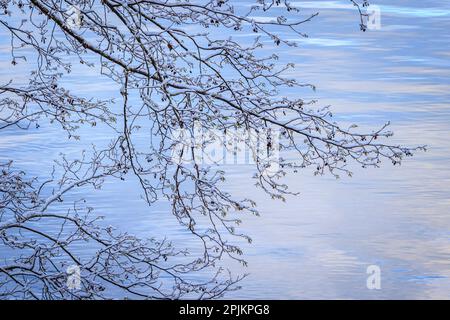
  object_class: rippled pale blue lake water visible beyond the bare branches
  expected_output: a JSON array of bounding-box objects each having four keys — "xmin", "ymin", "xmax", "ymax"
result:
[{"xmin": 0, "ymin": 0, "xmax": 450, "ymax": 299}]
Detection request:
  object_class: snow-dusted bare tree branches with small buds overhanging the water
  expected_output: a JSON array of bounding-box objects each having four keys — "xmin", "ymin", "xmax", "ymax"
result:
[{"xmin": 0, "ymin": 0, "xmax": 424, "ymax": 299}]
